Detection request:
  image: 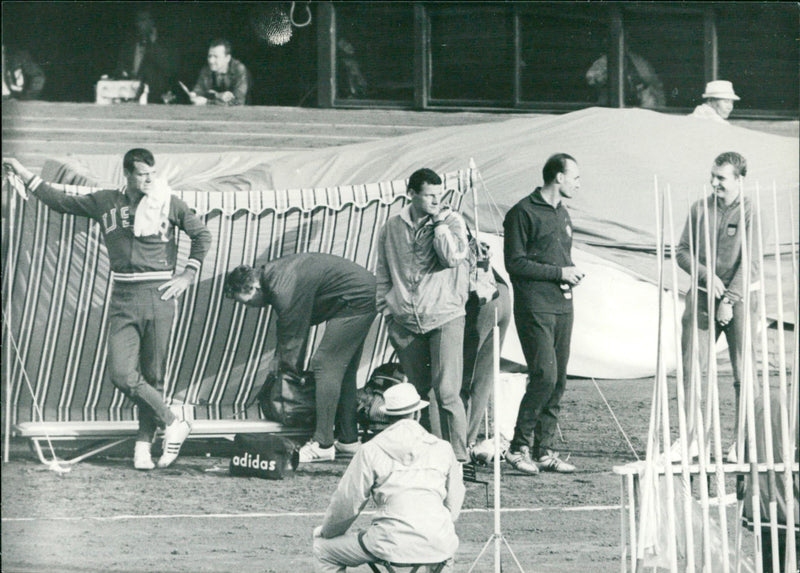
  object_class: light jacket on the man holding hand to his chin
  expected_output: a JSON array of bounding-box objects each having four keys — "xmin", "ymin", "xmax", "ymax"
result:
[{"xmin": 375, "ymin": 205, "xmax": 469, "ymax": 334}]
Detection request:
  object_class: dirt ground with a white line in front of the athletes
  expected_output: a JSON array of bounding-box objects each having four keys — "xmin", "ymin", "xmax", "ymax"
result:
[{"xmin": 2, "ymin": 379, "xmax": 752, "ymax": 573}]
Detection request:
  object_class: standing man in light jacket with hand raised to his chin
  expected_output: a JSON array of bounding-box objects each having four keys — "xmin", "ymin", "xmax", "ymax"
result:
[{"xmin": 375, "ymin": 168, "xmax": 469, "ymax": 462}]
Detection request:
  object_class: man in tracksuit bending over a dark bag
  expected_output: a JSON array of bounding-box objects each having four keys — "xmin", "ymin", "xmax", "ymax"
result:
[{"xmin": 225, "ymin": 253, "xmax": 377, "ymax": 463}]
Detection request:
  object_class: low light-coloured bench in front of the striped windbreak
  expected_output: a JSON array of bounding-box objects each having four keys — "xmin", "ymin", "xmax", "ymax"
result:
[{"xmin": 14, "ymin": 419, "xmax": 311, "ymax": 464}]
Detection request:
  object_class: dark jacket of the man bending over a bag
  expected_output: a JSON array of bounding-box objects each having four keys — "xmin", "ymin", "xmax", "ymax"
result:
[{"xmin": 260, "ymin": 253, "xmax": 376, "ymax": 369}]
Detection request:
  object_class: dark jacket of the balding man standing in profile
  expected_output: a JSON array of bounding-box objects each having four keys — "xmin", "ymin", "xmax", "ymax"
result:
[{"xmin": 503, "ymin": 187, "xmax": 573, "ymax": 314}]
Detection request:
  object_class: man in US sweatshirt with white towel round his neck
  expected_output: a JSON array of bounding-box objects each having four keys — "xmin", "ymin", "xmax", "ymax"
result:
[{"xmin": 3, "ymin": 149, "xmax": 211, "ymax": 470}]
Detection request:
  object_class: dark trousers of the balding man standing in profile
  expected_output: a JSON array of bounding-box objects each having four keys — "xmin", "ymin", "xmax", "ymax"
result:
[{"xmin": 511, "ymin": 305, "xmax": 573, "ymax": 457}]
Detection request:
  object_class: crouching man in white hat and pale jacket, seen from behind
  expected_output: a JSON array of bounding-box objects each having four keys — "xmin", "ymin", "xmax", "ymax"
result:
[{"xmin": 314, "ymin": 382, "xmax": 464, "ymax": 573}]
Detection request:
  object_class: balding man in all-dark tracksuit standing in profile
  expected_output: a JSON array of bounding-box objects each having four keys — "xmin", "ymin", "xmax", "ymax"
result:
[{"xmin": 503, "ymin": 153, "xmax": 584, "ymax": 474}]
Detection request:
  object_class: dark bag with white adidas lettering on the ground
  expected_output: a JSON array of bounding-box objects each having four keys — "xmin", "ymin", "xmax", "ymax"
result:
[{"xmin": 229, "ymin": 434, "xmax": 300, "ymax": 479}]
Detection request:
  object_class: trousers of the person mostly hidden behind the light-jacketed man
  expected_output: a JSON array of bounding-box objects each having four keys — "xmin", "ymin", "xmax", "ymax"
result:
[{"xmin": 461, "ymin": 283, "xmax": 511, "ymax": 445}]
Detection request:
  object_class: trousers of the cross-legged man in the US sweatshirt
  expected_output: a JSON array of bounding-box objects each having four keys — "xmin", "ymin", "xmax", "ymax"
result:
[{"xmin": 107, "ymin": 282, "xmax": 177, "ymax": 442}]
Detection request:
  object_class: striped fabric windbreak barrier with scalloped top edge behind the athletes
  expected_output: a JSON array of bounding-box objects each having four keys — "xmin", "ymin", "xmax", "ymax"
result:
[{"xmin": 2, "ymin": 171, "xmax": 471, "ymax": 425}]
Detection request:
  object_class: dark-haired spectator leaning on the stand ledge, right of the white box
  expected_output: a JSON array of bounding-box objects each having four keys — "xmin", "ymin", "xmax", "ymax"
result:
[{"xmin": 189, "ymin": 39, "xmax": 250, "ymax": 105}]
